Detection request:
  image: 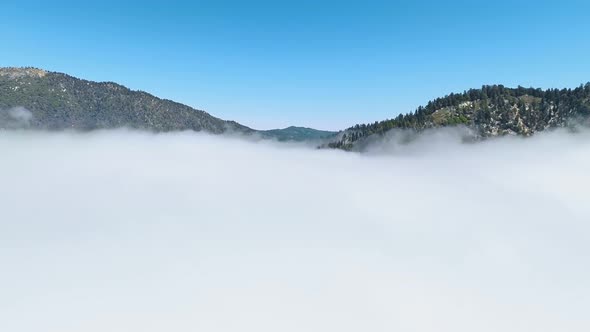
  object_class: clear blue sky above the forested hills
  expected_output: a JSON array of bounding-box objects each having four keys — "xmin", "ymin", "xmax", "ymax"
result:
[{"xmin": 0, "ymin": 0, "xmax": 590, "ymax": 129}]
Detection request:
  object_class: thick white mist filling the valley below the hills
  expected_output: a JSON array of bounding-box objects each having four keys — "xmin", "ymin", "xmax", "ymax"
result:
[{"xmin": 0, "ymin": 130, "xmax": 590, "ymax": 332}]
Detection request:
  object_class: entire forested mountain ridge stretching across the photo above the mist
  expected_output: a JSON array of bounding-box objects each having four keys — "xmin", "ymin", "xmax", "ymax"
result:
[{"xmin": 0, "ymin": 67, "xmax": 590, "ymax": 150}]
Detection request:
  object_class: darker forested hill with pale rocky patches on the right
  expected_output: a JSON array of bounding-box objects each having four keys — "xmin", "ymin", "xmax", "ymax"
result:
[{"xmin": 329, "ymin": 83, "xmax": 590, "ymax": 150}]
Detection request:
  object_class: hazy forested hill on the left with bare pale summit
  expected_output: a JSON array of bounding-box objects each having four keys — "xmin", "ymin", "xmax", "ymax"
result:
[{"xmin": 0, "ymin": 68, "xmax": 254, "ymax": 134}]
